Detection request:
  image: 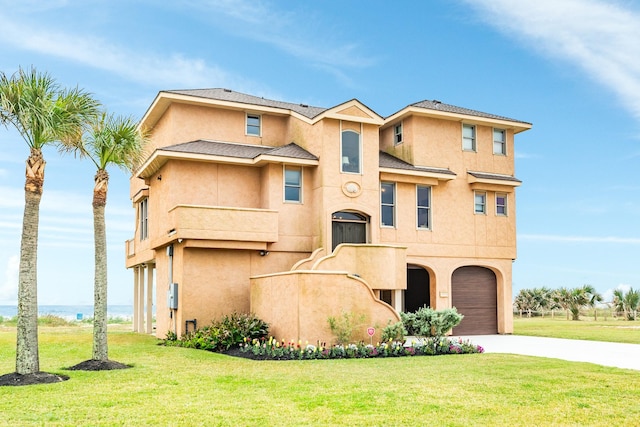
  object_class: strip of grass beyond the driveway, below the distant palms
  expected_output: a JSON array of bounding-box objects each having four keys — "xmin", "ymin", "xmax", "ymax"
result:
[{"xmin": 513, "ymin": 316, "xmax": 640, "ymax": 344}]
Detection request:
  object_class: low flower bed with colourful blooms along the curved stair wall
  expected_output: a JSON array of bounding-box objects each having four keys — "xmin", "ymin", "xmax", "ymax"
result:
[{"xmin": 227, "ymin": 337, "xmax": 484, "ymax": 360}]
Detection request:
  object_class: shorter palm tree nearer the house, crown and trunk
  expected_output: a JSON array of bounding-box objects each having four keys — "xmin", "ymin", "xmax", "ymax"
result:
[{"xmin": 70, "ymin": 113, "xmax": 148, "ymax": 370}]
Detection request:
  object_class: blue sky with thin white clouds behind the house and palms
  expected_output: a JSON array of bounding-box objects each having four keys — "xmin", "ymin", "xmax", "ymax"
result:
[{"xmin": 0, "ymin": 0, "xmax": 640, "ymax": 304}]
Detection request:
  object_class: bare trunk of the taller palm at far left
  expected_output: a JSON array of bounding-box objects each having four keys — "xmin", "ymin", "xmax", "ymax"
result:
[{"xmin": 16, "ymin": 148, "xmax": 46, "ymax": 375}]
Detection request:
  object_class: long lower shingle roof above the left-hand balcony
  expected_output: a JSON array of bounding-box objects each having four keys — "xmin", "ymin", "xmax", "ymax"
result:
[{"xmin": 161, "ymin": 140, "xmax": 318, "ymax": 160}]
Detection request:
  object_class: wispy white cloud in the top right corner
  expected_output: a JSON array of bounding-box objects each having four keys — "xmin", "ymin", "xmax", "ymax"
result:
[{"xmin": 462, "ymin": 0, "xmax": 640, "ymax": 120}]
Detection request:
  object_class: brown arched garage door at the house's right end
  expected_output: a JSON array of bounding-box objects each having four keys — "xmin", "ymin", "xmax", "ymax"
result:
[{"xmin": 451, "ymin": 267, "xmax": 498, "ymax": 335}]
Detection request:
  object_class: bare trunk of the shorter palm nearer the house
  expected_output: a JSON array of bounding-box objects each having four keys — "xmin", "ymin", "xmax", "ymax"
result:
[{"xmin": 93, "ymin": 169, "xmax": 109, "ymax": 361}]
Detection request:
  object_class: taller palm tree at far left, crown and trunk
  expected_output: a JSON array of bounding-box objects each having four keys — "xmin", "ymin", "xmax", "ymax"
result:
[{"xmin": 0, "ymin": 68, "xmax": 99, "ymax": 375}]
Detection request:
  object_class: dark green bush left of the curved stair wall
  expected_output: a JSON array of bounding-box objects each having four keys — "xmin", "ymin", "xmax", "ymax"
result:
[{"xmin": 164, "ymin": 313, "xmax": 269, "ymax": 351}]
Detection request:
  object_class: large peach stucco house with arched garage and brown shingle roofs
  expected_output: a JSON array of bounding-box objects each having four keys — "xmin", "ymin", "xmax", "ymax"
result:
[{"xmin": 126, "ymin": 89, "xmax": 531, "ymax": 342}]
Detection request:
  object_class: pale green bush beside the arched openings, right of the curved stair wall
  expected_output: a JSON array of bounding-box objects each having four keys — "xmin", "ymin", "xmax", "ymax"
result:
[{"xmin": 400, "ymin": 307, "xmax": 464, "ymax": 337}]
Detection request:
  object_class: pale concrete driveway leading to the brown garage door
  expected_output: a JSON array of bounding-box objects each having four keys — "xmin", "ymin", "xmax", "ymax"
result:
[{"xmin": 462, "ymin": 335, "xmax": 640, "ymax": 371}]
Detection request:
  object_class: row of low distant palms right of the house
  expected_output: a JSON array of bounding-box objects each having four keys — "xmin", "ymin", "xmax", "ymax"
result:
[{"xmin": 513, "ymin": 285, "xmax": 640, "ymax": 320}]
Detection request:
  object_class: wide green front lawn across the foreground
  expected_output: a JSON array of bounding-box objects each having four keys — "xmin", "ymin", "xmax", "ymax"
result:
[{"xmin": 0, "ymin": 325, "xmax": 640, "ymax": 426}]
